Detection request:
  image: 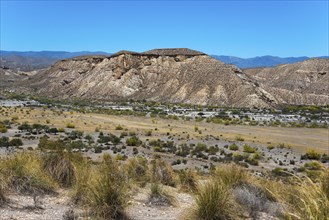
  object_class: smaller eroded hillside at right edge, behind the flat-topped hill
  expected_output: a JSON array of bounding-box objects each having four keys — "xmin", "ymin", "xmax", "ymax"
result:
[{"xmin": 245, "ymin": 59, "xmax": 329, "ymax": 105}]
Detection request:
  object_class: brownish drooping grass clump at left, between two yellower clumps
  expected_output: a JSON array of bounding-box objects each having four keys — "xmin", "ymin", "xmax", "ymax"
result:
[{"xmin": 43, "ymin": 152, "xmax": 76, "ymax": 187}]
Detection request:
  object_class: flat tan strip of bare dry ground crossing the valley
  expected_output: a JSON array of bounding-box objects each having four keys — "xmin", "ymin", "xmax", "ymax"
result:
[{"xmin": 0, "ymin": 108, "xmax": 329, "ymax": 153}]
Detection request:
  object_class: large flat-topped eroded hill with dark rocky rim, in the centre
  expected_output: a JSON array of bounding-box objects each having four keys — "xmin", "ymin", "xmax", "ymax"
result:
[{"xmin": 25, "ymin": 50, "xmax": 276, "ymax": 107}]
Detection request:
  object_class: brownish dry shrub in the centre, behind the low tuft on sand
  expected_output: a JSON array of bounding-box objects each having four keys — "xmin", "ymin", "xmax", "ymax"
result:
[{"xmin": 150, "ymin": 156, "xmax": 176, "ymax": 186}]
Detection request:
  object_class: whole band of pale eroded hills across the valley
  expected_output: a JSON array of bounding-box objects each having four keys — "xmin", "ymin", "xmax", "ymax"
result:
[{"xmin": 5, "ymin": 48, "xmax": 329, "ymax": 108}]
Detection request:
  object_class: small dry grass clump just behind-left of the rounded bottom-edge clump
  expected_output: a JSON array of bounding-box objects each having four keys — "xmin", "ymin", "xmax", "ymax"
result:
[{"xmin": 178, "ymin": 169, "xmax": 197, "ymax": 192}]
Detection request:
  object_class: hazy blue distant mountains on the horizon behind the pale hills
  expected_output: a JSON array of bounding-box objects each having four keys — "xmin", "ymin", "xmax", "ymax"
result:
[{"xmin": 0, "ymin": 50, "xmax": 329, "ymax": 71}]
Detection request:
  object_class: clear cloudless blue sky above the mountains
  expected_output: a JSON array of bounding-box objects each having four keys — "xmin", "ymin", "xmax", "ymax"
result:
[{"xmin": 0, "ymin": 0, "xmax": 329, "ymax": 58}]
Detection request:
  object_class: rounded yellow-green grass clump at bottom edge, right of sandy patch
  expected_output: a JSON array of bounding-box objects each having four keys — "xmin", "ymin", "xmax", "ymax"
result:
[{"xmin": 191, "ymin": 180, "xmax": 236, "ymax": 220}]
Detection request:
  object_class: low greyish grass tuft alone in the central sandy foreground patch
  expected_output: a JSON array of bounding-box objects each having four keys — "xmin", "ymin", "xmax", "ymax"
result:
[{"xmin": 148, "ymin": 183, "xmax": 176, "ymax": 206}]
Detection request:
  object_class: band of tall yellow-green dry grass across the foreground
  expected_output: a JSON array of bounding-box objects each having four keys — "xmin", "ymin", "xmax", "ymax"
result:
[{"xmin": 0, "ymin": 151, "xmax": 329, "ymax": 220}]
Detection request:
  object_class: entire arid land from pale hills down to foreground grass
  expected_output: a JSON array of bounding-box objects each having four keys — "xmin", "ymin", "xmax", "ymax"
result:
[{"xmin": 0, "ymin": 49, "xmax": 329, "ymax": 220}]
